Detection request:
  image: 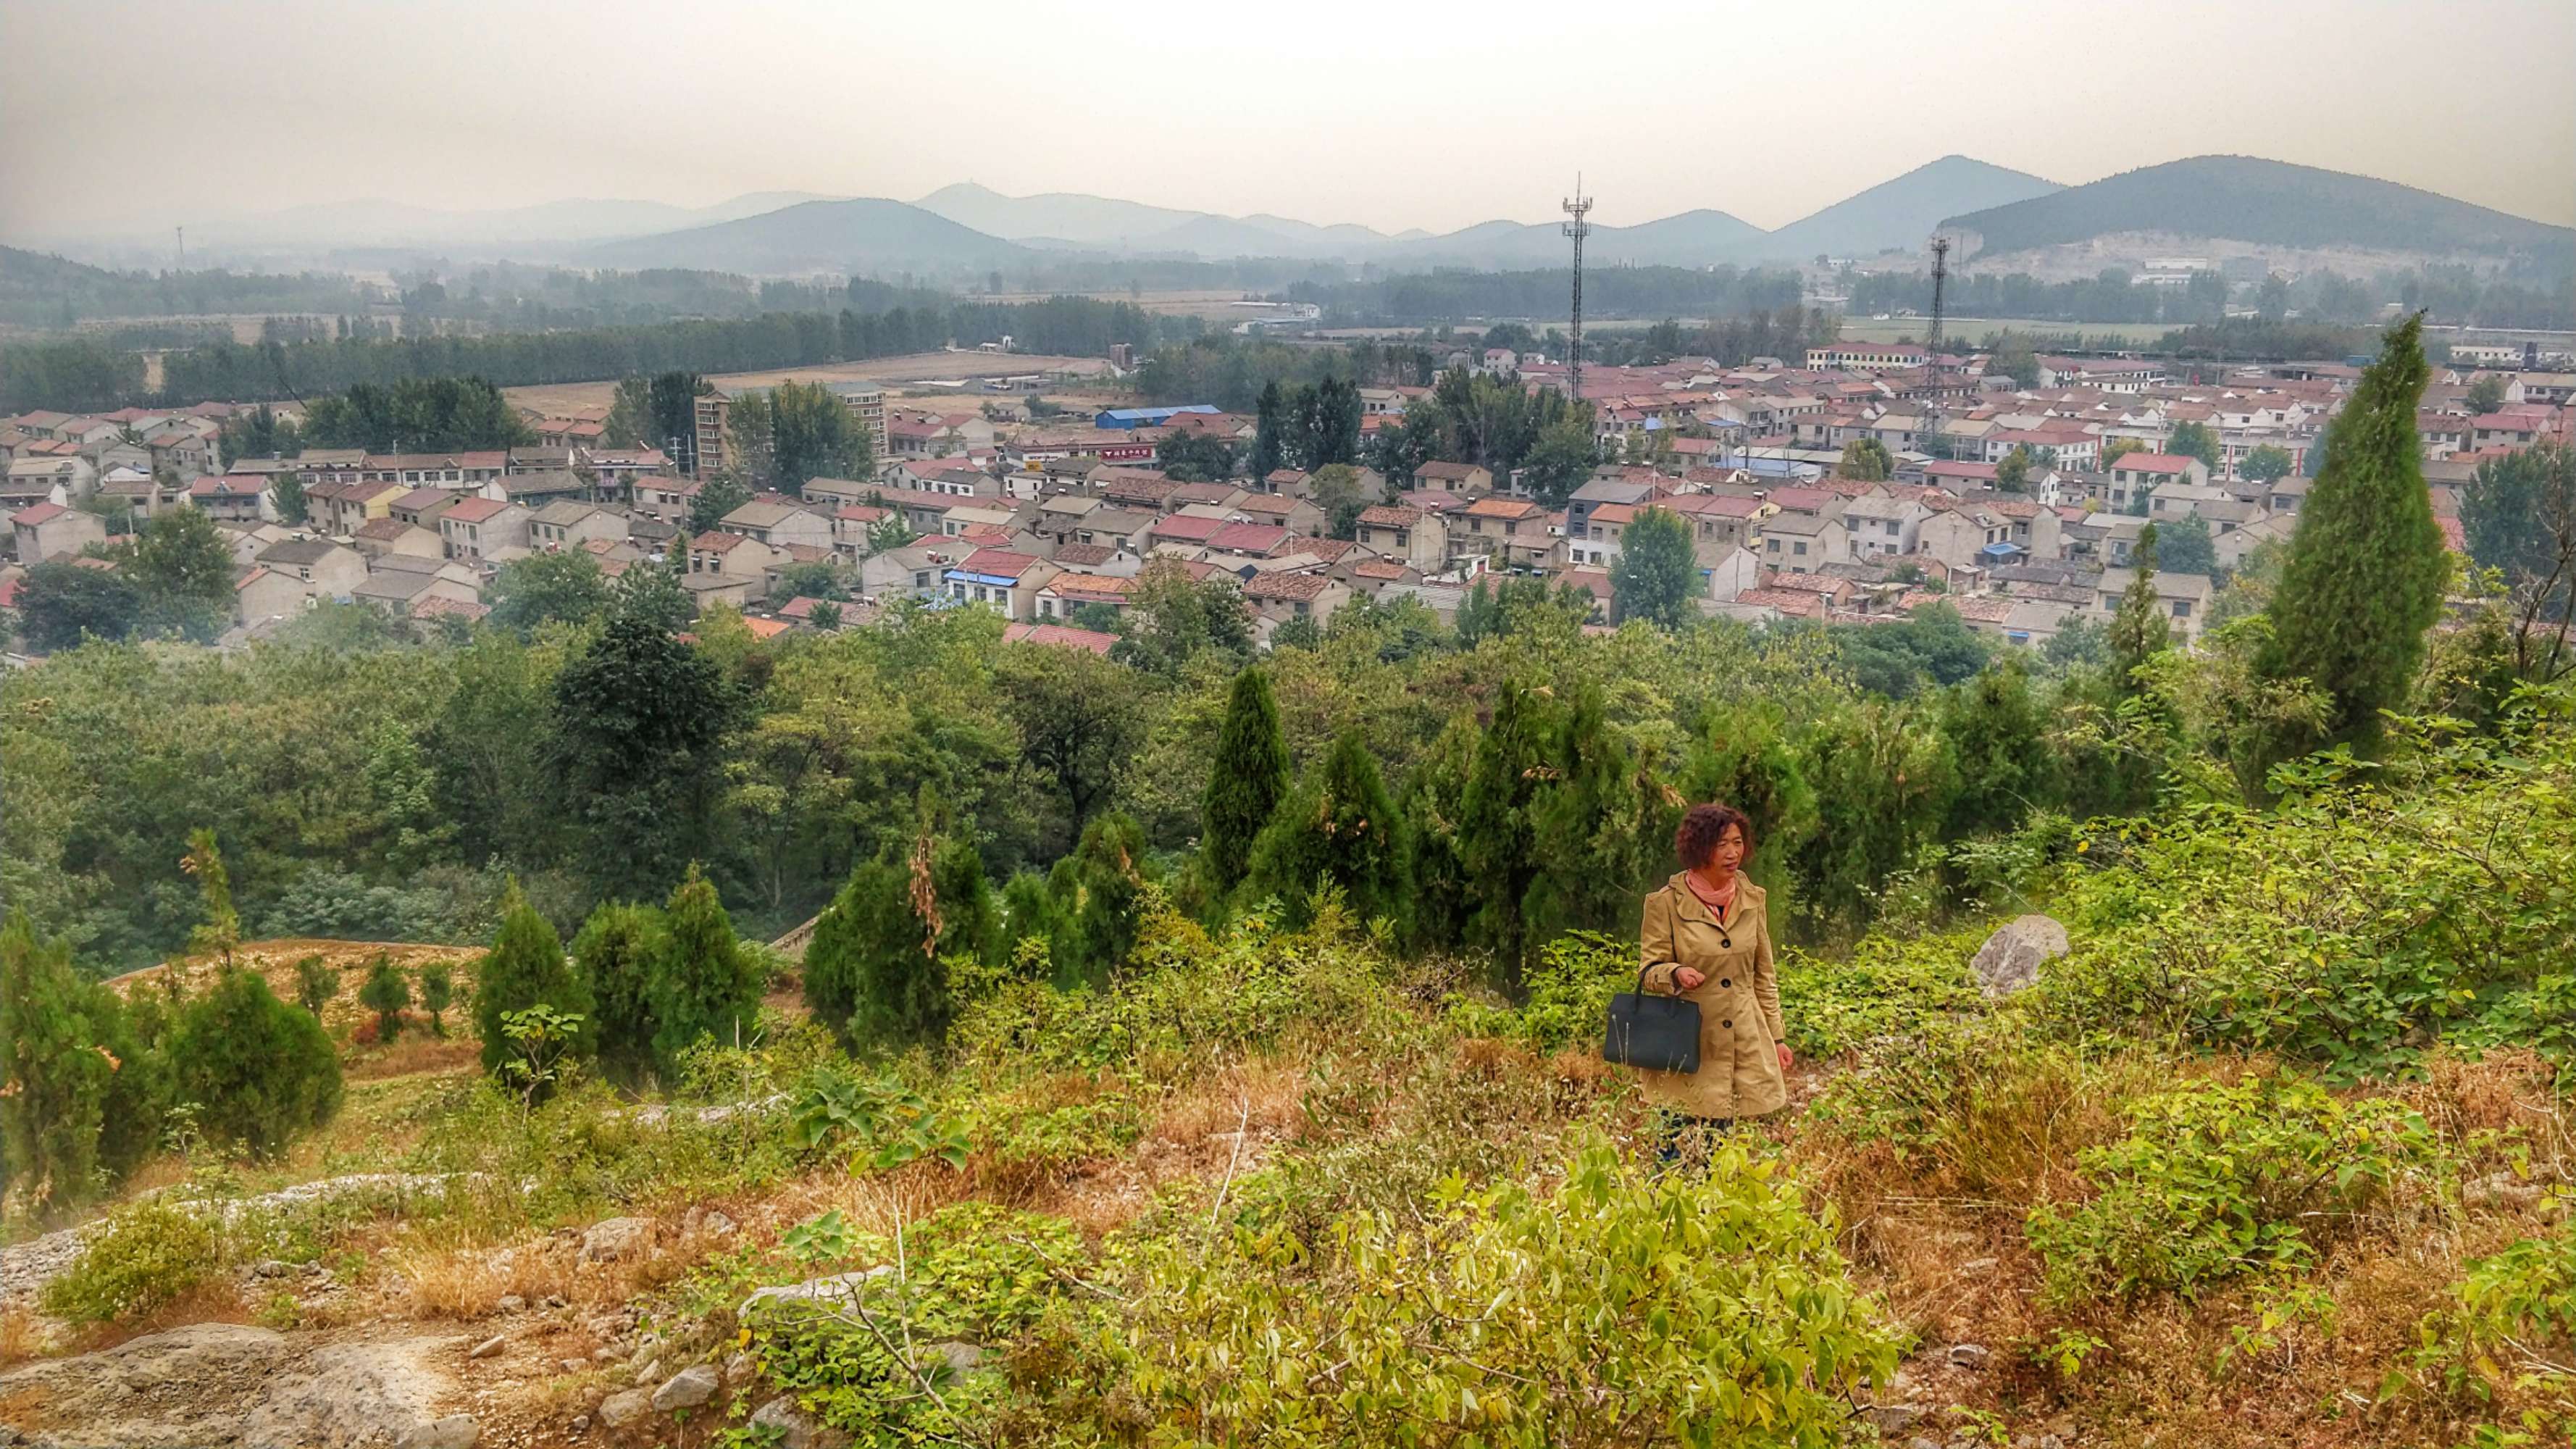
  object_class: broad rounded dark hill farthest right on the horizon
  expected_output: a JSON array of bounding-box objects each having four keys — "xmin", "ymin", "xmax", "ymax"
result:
[{"xmin": 1942, "ymin": 155, "xmax": 2576, "ymax": 255}]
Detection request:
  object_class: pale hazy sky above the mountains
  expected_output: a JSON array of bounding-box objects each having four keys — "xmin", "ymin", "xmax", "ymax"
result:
[{"xmin": 0, "ymin": 0, "xmax": 2576, "ymax": 240}]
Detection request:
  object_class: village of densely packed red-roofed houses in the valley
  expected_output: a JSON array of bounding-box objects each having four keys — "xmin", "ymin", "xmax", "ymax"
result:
[{"xmin": 0, "ymin": 327, "xmax": 2576, "ymax": 652}]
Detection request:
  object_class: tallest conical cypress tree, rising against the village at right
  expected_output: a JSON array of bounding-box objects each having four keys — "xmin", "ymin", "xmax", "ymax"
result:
[{"xmin": 2262, "ymin": 314, "xmax": 2450, "ymax": 753}]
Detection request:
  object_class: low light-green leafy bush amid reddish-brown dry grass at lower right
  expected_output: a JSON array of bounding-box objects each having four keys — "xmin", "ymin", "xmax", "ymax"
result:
[{"xmin": 2028, "ymin": 1075, "xmax": 2440, "ymax": 1302}]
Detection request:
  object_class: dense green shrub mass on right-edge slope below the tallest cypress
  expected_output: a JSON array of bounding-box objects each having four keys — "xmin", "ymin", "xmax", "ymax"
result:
[{"xmin": 2045, "ymin": 727, "xmax": 2576, "ymax": 1080}]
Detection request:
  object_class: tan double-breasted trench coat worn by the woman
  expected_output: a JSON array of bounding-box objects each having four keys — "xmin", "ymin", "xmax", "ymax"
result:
[{"xmin": 1639, "ymin": 872, "xmax": 1788, "ymax": 1116}]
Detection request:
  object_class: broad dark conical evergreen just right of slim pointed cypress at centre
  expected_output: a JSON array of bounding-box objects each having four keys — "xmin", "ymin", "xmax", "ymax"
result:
[{"xmin": 1250, "ymin": 727, "xmax": 1404, "ymax": 926}]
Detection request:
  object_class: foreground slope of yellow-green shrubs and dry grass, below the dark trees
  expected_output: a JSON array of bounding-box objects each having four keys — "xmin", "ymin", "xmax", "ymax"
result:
[{"xmin": 0, "ymin": 693, "xmax": 2576, "ymax": 1446}]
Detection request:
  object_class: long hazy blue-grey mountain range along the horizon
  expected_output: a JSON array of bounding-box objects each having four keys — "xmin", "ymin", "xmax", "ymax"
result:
[{"xmin": 20, "ymin": 155, "xmax": 2576, "ymax": 281}]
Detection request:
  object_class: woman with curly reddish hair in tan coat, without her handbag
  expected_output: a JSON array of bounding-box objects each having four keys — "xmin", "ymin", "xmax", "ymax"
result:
[{"xmin": 1639, "ymin": 804, "xmax": 1793, "ymax": 1166}]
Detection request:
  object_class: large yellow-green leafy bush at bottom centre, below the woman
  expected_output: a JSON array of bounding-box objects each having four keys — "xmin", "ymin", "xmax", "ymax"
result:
[{"xmin": 1056, "ymin": 1145, "xmax": 1899, "ymax": 1449}]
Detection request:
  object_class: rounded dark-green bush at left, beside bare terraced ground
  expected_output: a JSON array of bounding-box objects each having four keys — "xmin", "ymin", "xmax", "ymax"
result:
[{"xmin": 167, "ymin": 969, "xmax": 340, "ymax": 1158}]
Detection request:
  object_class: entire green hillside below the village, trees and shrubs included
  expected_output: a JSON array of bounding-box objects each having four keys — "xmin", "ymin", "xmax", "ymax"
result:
[{"xmin": 0, "ymin": 325, "xmax": 2576, "ymax": 1449}]
